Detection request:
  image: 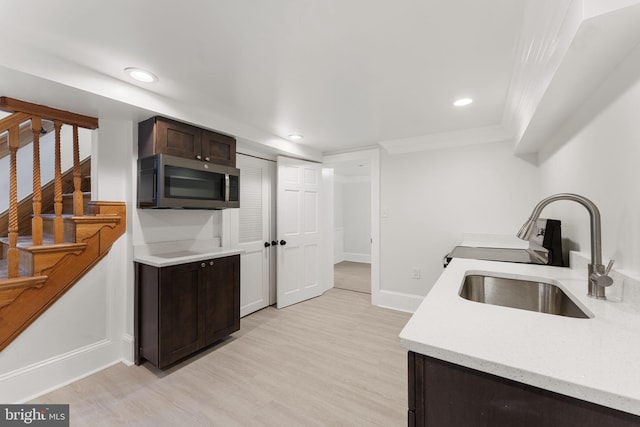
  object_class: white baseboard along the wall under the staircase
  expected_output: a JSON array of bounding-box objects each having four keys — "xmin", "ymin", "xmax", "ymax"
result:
[{"xmin": 0, "ymin": 339, "xmax": 121, "ymax": 403}]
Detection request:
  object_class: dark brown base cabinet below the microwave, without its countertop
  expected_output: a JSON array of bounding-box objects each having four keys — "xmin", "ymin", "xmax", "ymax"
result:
[{"xmin": 135, "ymin": 255, "xmax": 240, "ymax": 369}]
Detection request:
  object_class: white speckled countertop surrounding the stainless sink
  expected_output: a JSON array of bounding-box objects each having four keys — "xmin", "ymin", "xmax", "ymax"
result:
[{"xmin": 400, "ymin": 259, "xmax": 640, "ymax": 415}]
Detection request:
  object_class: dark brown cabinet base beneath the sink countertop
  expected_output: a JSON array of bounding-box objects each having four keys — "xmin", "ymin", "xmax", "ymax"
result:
[{"xmin": 408, "ymin": 352, "xmax": 640, "ymax": 427}]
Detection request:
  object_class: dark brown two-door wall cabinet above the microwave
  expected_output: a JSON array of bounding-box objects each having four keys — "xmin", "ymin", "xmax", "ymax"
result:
[{"xmin": 138, "ymin": 116, "xmax": 236, "ymax": 167}]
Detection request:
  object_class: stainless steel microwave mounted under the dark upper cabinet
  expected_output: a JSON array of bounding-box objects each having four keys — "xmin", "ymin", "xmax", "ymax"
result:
[{"xmin": 138, "ymin": 154, "xmax": 240, "ymax": 209}]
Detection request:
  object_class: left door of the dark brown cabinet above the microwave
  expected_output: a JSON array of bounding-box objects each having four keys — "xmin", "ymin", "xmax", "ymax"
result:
[{"xmin": 156, "ymin": 119, "xmax": 202, "ymax": 159}]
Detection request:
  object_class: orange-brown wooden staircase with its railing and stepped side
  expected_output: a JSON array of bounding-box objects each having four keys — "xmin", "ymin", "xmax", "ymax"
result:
[{"xmin": 0, "ymin": 97, "xmax": 126, "ymax": 350}]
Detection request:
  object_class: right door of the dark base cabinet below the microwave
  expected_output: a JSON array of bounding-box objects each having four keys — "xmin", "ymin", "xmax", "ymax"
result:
[{"xmin": 203, "ymin": 255, "xmax": 240, "ymax": 344}]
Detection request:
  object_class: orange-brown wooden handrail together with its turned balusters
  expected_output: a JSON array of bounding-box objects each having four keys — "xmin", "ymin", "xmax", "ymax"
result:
[{"xmin": 0, "ymin": 96, "xmax": 98, "ymax": 278}]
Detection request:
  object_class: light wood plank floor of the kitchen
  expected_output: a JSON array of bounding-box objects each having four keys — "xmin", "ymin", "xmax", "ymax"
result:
[{"xmin": 33, "ymin": 289, "xmax": 410, "ymax": 427}]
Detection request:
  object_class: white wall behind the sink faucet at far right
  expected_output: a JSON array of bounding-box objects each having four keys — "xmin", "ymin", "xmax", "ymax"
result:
[{"xmin": 540, "ymin": 74, "xmax": 640, "ymax": 276}]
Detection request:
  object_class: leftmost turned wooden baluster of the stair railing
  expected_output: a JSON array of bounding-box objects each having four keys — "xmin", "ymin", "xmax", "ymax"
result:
[{"xmin": 7, "ymin": 125, "xmax": 20, "ymax": 279}]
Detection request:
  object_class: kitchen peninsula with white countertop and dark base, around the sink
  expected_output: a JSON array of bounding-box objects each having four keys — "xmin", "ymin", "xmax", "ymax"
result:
[{"xmin": 400, "ymin": 259, "xmax": 640, "ymax": 427}]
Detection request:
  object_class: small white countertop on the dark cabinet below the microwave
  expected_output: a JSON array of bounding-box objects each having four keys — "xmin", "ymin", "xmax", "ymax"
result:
[{"xmin": 133, "ymin": 239, "xmax": 244, "ymax": 267}]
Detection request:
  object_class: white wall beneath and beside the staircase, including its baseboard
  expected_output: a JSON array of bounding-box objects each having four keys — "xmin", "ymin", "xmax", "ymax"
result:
[{"xmin": 0, "ymin": 120, "xmax": 133, "ymax": 403}]
